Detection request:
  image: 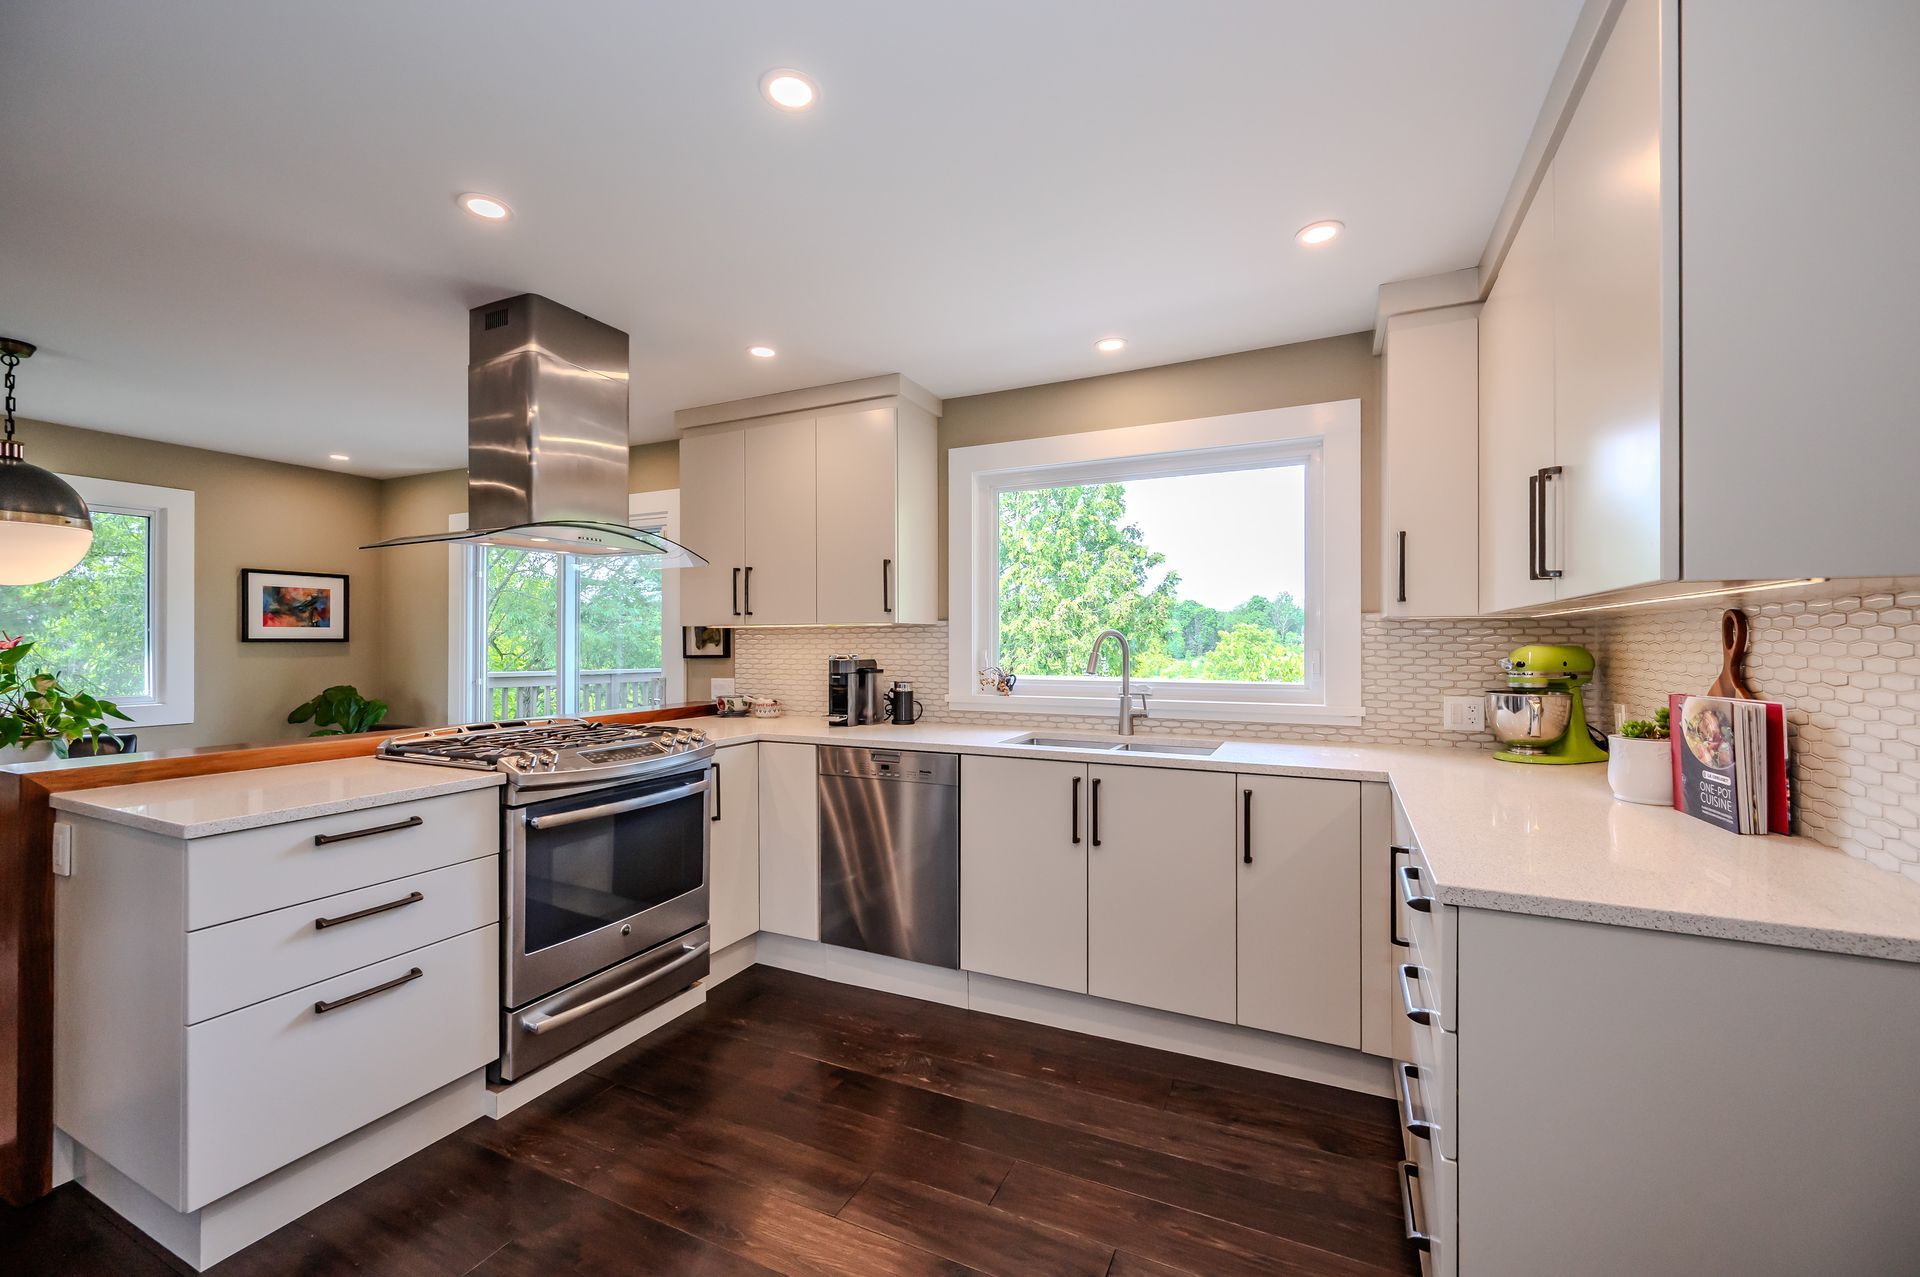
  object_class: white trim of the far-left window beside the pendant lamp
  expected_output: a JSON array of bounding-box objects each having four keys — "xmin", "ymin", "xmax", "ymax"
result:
[{"xmin": 45, "ymin": 474, "xmax": 194, "ymax": 730}]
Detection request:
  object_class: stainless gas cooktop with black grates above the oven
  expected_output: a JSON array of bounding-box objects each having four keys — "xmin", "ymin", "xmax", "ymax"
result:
[{"xmin": 380, "ymin": 718, "xmax": 712, "ymax": 787}]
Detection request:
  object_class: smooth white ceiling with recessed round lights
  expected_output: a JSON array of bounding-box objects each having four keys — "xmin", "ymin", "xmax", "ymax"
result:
[{"xmin": 0, "ymin": 0, "xmax": 1580, "ymax": 474}]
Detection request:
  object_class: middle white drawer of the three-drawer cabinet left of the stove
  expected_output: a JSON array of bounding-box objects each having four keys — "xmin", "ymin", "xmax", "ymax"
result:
[{"xmin": 186, "ymin": 856, "xmax": 499, "ymax": 1024}]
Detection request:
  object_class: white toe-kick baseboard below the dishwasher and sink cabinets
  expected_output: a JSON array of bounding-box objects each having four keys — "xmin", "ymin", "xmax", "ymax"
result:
[{"xmin": 741, "ymin": 931, "xmax": 1394, "ymax": 1095}]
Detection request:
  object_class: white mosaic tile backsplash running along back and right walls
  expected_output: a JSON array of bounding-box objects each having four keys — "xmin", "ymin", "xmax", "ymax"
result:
[{"xmin": 733, "ymin": 578, "xmax": 1920, "ymax": 881}]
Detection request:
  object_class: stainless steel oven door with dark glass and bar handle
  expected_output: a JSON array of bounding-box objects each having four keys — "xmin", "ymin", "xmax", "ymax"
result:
[{"xmin": 503, "ymin": 768, "xmax": 708, "ymax": 1008}]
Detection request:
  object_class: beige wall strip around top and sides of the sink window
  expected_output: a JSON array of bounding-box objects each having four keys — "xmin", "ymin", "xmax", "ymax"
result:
[{"xmin": 933, "ymin": 332, "xmax": 1380, "ymax": 616}]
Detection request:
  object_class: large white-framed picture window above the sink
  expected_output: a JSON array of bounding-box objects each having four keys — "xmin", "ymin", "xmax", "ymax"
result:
[{"xmin": 948, "ymin": 401, "xmax": 1359, "ymax": 722}]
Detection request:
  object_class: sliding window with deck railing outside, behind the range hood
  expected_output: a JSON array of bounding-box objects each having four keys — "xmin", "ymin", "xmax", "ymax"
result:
[{"xmin": 449, "ymin": 492, "xmax": 684, "ymax": 722}]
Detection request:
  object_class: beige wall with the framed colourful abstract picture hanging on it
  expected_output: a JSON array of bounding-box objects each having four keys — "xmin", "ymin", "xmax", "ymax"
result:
[{"xmin": 19, "ymin": 421, "xmax": 396, "ymax": 749}]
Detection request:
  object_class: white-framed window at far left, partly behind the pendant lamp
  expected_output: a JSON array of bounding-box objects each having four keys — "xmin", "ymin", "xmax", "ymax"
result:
[{"xmin": 0, "ymin": 474, "xmax": 194, "ymax": 730}]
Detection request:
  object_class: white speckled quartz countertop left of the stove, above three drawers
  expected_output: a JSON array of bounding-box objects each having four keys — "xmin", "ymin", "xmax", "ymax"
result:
[{"xmin": 50, "ymin": 759, "xmax": 507, "ymax": 837}]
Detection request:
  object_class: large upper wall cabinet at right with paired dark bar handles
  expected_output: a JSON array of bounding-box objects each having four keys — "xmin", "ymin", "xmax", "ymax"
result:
[{"xmin": 1474, "ymin": 0, "xmax": 1920, "ymax": 611}]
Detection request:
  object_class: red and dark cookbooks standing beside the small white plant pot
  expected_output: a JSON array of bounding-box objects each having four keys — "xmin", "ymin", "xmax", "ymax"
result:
[{"xmin": 1667, "ymin": 695, "xmax": 1789, "ymax": 833}]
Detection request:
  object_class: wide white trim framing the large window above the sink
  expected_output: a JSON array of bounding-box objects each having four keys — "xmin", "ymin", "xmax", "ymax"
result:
[{"xmin": 947, "ymin": 399, "xmax": 1365, "ymax": 724}]
